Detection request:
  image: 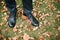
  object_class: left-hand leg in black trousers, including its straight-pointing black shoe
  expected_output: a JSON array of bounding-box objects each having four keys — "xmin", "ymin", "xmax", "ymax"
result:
[{"xmin": 5, "ymin": 0, "xmax": 17, "ymax": 28}]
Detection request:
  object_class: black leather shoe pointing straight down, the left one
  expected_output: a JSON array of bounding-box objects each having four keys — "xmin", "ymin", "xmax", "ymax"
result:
[{"xmin": 8, "ymin": 9, "xmax": 17, "ymax": 28}]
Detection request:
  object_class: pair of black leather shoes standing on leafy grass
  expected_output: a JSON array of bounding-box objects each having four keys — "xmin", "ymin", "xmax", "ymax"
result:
[{"xmin": 8, "ymin": 9, "xmax": 39, "ymax": 28}]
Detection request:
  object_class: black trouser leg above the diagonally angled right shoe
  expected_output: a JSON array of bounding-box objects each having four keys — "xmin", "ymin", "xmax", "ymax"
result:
[{"xmin": 22, "ymin": 0, "xmax": 33, "ymax": 11}]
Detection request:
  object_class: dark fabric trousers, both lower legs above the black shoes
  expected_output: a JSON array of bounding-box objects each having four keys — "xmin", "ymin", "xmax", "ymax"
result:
[{"xmin": 5, "ymin": 0, "xmax": 33, "ymax": 12}]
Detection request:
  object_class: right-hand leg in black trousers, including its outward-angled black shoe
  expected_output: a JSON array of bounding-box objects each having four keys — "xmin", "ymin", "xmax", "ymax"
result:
[{"xmin": 22, "ymin": 0, "xmax": 39, "ymax": 26}]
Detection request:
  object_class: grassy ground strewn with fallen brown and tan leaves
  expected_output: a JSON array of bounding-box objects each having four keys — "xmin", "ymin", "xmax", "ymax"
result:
[{"xmin": 0, "ymin": 0, "xmax": 60, "ymax": 40}]
